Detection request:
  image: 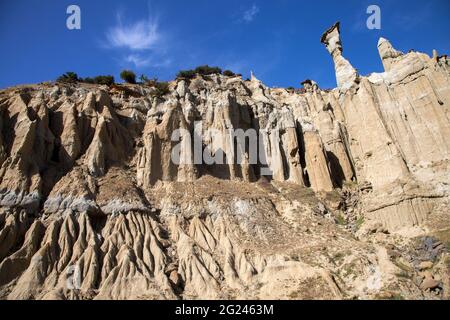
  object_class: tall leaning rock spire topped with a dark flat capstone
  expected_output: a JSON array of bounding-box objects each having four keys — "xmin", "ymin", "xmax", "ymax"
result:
[{"xmin": 320, "ymin": 22, "xmax": 359, "ymax": 90}]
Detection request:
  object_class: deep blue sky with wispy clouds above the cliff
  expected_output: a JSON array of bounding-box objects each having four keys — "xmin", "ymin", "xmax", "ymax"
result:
[{"xmin": 0, "ymin": 0, "xmax": 450, "ymax": 88}]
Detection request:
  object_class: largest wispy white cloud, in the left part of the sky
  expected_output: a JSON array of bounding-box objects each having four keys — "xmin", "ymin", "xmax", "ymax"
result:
[{"xmin": 107, "ymin": 15, "xmax": 161, "ymax": 51}]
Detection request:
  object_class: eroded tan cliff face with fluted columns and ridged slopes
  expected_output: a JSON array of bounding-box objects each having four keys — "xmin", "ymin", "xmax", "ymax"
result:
[{"xmin": 0, "ymin": 24, "xmax": 450, "ymax": 299}]
